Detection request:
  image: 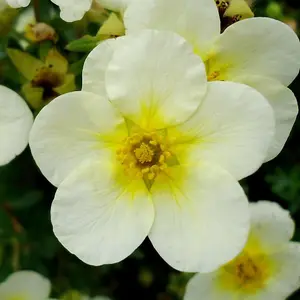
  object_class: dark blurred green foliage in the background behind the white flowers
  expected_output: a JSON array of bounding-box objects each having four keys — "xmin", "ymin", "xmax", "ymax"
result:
[{"xmin": 0, "ymin": 0, "xmax": 300, "ymax": 300}]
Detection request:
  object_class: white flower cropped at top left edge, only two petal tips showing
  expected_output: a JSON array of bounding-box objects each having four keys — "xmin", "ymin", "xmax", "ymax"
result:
[{"xmin": 6, "ymin": 0, "xmax": 93, "ymax": 22}]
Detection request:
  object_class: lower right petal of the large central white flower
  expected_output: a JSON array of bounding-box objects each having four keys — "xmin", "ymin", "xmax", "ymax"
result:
[{"xmin": 149, "ymin": 163, "xmax": 249, "ymax": 272}]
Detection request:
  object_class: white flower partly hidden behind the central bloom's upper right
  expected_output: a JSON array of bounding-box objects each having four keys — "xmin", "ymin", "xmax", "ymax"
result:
[{"xmin": 124, "ymin": 0, "xmax": 300, "ymax": 161}]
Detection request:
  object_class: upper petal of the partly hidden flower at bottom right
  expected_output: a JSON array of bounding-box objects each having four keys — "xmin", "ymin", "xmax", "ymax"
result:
[{"xmin": 250, "ymin": 201, "xmax": 295, "ymax": 251}]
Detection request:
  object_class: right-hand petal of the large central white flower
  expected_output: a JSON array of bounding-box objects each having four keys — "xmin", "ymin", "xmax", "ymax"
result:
[{"xmin": 170, "ymin": 82, "xmax": 275, "ymax": 180}]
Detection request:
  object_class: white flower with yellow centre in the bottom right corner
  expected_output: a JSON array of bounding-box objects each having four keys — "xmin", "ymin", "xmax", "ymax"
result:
[{"xmin": 184, "ymin": 201, "xmax": 300, "ymax": 300}]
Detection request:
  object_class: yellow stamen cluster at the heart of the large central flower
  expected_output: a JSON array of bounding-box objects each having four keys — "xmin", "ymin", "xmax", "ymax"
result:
[{"xmin": 117, "ymin": 132, "xmax": 172, "ymax": 180}]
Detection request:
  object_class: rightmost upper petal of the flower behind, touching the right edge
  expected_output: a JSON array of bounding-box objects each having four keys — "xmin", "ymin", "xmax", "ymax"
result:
[{"xmin": 214, "ymin": 18, "xmax": 300, "ymax": 85}]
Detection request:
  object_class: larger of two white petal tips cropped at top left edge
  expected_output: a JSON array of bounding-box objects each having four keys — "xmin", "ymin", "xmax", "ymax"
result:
[{"xmin": 51, "ymin": 0, "xmax": 92, "ymax": 22}]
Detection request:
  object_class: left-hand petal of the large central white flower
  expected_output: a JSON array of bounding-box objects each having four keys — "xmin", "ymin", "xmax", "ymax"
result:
[{"xmin": 30, "ymin": 92, "xmax": 127, "ymax": 186}]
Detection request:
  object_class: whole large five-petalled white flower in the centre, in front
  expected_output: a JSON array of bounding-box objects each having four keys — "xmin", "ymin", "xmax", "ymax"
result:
[{"xmin": 30, "ymin": 31, "xmax": 274, "ymax": 271}]
